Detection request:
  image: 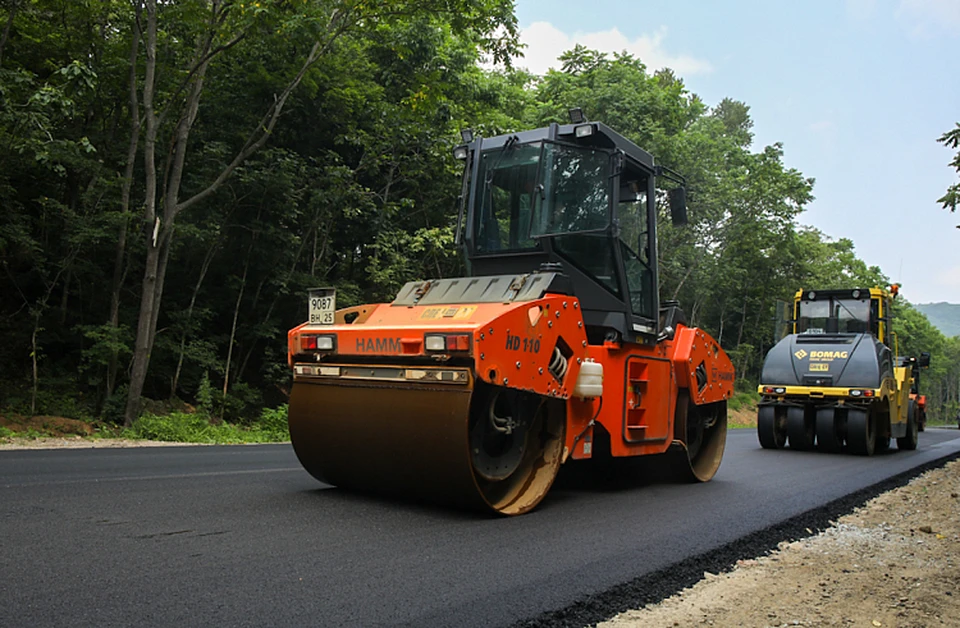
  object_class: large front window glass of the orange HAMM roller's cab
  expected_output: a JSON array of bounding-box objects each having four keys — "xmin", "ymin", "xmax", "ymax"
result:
[{"xmin": 476, "ymin": 142, "xmax": 612, "ymax": 253}]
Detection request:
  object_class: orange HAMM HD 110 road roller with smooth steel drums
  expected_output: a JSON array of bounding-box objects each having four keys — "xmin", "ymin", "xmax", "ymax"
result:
[{"xmin": 288, "ymin": 111, "xmax": 734, "ymax": 515}]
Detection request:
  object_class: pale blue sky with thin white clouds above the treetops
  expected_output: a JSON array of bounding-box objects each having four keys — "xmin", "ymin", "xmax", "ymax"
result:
[{"xmin": 515, "ymin": 0, "xmax": 960, "ymax": 303}]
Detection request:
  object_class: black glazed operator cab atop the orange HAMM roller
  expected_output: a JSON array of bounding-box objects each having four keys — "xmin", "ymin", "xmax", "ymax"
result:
[{"xmin": 458, "ymin": 122, "xmax": 685, "ymax": 344}]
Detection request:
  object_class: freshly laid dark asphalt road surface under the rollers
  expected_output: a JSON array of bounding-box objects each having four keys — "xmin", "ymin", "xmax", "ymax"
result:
[{"xmin": 0, "ymin": 429, "xmax": 960, "ymax": 627}]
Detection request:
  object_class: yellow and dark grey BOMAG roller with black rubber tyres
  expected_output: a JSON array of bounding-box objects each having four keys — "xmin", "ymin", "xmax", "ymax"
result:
[{"xmin": 757, "ymin": 286, "xmax": 930, "ymax": 456}]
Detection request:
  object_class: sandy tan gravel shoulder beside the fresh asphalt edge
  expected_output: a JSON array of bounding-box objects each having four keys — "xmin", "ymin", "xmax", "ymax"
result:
[{"xmin": 599, "ymin": 460, "xmax": 960, "ymax": 628}]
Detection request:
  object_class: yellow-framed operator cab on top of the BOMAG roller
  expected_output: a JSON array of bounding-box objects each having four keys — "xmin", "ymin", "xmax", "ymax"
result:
[{"xmin": 794, "ymin": 288, "xmax": 893, "ymax": 346}]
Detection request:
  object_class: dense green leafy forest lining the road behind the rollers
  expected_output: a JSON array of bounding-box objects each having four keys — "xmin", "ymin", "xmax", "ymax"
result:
[{"xmin": 0, "ymin": 0, "xmax": 960, "ymax": 424}]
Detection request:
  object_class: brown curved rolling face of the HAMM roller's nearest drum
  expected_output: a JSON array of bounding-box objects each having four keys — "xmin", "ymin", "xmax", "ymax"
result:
[{"xmin": 289, "ymin": 381, "xmax": 480, "ymax": 510}]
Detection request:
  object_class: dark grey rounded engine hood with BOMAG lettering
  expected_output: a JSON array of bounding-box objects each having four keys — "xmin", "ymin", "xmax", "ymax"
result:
[{"xmin": 760, "ymin": 333, "xmax": 892, "ymax": 388}]
